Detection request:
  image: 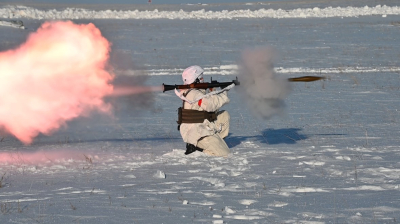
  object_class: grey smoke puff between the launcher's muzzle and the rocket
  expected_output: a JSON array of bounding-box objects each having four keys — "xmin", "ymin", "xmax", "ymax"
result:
[{"xmin": 237, "ymin": 47, "xmax": 291, "ymax": 119}]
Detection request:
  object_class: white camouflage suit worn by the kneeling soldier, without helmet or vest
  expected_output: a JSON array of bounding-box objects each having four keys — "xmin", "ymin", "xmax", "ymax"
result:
[{"xmin": 180, "ymin": 89, "xmax": 230, "ymax": 157}]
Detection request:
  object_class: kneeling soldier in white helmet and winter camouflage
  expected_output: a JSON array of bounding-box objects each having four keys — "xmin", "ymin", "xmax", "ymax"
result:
[{"xmin": 178, "ymin": 65, "xmax": 230, "ymax": 157}]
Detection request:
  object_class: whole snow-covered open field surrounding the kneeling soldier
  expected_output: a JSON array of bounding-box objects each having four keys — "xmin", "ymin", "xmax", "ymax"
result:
[{"xmin": 0, "ymin": 0, "xmax": 400, "ymax": 223}]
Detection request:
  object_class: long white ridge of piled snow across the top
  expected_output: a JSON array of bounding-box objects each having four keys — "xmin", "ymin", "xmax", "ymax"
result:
[{"xmin": 0, "ymin": 5, "xmax": 400, "ymax": 19}]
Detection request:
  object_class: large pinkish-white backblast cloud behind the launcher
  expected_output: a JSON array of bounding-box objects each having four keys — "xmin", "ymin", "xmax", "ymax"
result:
[{"xmin": 0, "ymin": 21, "xmax": 113, "ymax": 144}]
